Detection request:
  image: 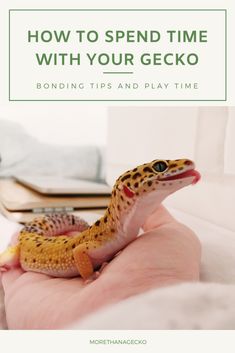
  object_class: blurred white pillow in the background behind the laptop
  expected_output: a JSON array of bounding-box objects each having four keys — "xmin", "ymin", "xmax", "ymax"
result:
[{"xmin": 0, "ymin": 119, "xmax": 102, "ymax": 180}]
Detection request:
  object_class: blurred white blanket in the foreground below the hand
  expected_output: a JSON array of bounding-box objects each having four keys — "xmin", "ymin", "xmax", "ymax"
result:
[{"xmin": 74, "ymin": 283, "xmax": 235, "ymax": 330}]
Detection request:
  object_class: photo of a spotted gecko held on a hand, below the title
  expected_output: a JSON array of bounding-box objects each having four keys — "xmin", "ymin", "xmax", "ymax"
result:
[{"xmin": 0, "ymin": 106, "xmax": 235, "ymax": 330}]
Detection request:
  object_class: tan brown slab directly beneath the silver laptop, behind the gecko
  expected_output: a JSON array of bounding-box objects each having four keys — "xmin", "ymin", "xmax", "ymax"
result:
[{"xmin": 0, "ymin": 179, "xmax": 110, "ymax": 213}]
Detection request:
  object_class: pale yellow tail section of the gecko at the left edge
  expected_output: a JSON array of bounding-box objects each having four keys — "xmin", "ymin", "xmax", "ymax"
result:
[{"xmin": 0, "ymin": 245, "xmax": 20, "ymax": 272}]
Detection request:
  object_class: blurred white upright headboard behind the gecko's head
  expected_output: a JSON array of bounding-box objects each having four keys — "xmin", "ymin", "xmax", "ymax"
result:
[{"xmin": 107, "ymin": 107, "xmax": 235, "ymax": 231}]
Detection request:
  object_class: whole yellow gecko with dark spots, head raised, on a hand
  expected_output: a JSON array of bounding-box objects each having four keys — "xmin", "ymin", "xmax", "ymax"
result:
[{"xmin": 0, "ymin": 159, "xmax": 200, "ymax": 279}]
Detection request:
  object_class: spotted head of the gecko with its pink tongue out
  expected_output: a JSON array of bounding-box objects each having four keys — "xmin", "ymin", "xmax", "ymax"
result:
[{"xmin": 115, "ymin": 159, "xmax": 200, "ymax": 198}]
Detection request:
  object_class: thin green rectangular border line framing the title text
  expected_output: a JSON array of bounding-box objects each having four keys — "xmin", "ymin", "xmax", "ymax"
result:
[{"xmin": 8, "ymin": 9, "xmax": 228, "ymax": 102}]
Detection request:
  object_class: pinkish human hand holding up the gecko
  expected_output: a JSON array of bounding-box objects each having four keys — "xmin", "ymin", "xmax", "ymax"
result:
[{"xmin": 2, "ymin": 206, "xmax": 201, "ymax": 329}]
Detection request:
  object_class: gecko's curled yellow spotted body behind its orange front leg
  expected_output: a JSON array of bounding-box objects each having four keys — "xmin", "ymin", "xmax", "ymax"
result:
[{"xmin": 19, "ymin": 213, "xmax": 89, "ymax": 277}]
